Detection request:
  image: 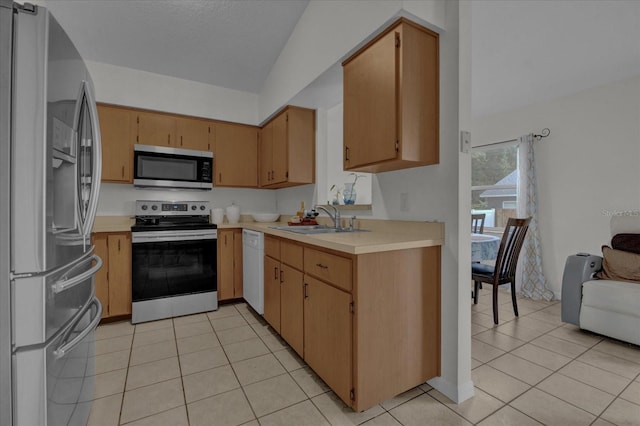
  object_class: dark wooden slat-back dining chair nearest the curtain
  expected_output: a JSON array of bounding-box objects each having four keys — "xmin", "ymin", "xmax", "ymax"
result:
[{"xmin": 471, "ymin": 217, "xmax": 531, "ymax": 324}]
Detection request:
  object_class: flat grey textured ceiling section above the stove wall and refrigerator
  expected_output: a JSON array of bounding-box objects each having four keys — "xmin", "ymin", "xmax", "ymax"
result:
[{"xmin": 39, "ymin": 0, "xmax": 308, "ymax": 93}]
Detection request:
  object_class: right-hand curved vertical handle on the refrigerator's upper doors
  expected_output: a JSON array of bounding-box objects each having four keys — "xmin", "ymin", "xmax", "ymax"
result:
[{"xmin": 83, "ymin": 81, "xmax": 102, "ymax": 239}]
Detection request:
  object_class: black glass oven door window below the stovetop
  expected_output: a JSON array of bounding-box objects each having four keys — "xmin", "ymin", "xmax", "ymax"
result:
[{"xmin": 132, "ymin": 239, "xmax": 218, "ymax": 302}]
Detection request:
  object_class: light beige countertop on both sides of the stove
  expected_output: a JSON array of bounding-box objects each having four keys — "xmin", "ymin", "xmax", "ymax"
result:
[{"xmin": 93, "ymin": 216, "xmax": 444, "ymax": 254}]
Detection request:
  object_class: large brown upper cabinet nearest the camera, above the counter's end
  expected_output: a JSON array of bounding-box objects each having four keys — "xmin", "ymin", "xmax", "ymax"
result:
[{"xmin": 342, "ymin": 18, "xmax": 439, "ymax": 173}]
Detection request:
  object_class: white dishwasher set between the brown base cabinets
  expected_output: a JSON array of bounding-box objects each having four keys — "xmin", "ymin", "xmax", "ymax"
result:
[{"xmin": 242, "ymin": 229, "xmax": 264, "ymax": 315}]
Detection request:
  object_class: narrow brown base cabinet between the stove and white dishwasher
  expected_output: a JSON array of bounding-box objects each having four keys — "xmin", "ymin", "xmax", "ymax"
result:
[{"xmin": 218, "ymin": 229, "xmax": 242, "ymax": 300}]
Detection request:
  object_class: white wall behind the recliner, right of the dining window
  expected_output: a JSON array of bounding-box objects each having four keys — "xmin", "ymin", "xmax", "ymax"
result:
[{"xmin": 472, "ymin": 76, "xmax": 640, "ymax": 298}]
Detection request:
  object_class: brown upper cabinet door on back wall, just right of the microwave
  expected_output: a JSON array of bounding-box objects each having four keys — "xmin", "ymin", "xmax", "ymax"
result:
[{"xmin": 214, "ymin": 123, "xmax": 258, "ymax": 188}]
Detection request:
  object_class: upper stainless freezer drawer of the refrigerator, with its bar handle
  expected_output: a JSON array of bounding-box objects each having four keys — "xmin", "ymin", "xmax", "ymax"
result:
[{"xmin": 11, "ymin": 251, "xmax": 102, "ymax": 347}]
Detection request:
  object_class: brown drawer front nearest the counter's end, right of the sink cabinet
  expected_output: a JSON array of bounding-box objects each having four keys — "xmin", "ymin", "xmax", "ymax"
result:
[{"xmin": 304, "ymin": 247, "xmax": 352, "ymax": 291}]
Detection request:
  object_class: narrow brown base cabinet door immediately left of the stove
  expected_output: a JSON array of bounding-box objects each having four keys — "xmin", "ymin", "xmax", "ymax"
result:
[{"xmin": 108, "ymin": 232, "xmax": 131, "ymax": 316}]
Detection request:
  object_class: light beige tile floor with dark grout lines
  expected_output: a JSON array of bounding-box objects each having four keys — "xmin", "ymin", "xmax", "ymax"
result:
[{"xmin": 89, "ymin": 290, "xmax": 640, "ymax": 426}]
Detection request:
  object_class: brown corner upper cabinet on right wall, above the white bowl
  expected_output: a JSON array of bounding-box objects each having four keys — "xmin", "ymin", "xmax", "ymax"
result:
[{"xmin": 259, "ymin": 106, "xmax": 316, "ymax": 188}]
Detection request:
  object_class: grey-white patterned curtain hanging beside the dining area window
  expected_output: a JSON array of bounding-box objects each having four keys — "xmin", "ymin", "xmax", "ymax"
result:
[{"xmin": 518, "ymin": 134, "xmax": 553, "ymax": 300}]
